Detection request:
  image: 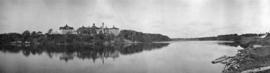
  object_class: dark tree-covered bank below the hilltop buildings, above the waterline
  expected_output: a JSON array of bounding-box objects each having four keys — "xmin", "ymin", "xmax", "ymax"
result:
[{"xmin": 0, "ymin": 30, "xmax": 170, "ymax": 45}]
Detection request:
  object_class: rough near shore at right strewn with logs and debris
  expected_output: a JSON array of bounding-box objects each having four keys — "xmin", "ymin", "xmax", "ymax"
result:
[{"xmin": 212, "ymin": 34, "xmax": 270, "ymax": 73}]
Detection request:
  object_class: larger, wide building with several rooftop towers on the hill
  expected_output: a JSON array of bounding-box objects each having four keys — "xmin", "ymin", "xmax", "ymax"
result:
[{"xmin": 77, "ymin": 23, "xmax": 120, "ymax": 36}]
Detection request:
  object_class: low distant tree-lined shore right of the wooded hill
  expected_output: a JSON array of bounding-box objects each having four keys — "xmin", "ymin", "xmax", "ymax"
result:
[{"xmin": 172, "ymin": 33, "xmax": 270, "ymax": 47}]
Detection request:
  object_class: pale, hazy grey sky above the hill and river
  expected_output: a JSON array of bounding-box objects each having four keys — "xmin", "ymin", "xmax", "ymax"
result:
[{"xmin": 0, "ymin": 0, "xmax": 270, "ymax": 38}]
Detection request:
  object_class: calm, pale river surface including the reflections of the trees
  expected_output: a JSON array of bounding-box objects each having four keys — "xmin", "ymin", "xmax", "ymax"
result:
[{"xmin": 0, "ymin": 41, "xmax": 241, "ymax": 73}]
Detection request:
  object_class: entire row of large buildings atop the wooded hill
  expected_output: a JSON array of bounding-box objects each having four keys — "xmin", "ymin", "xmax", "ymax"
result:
[{"xmin": 53, "ymin": 23, "xmax": 120, "ymax": 36}]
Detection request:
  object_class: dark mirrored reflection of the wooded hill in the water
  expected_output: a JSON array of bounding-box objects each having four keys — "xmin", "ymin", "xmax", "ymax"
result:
[{"xmin": 0, "ymin": 43, "xmax": 169, "ymax": 62}]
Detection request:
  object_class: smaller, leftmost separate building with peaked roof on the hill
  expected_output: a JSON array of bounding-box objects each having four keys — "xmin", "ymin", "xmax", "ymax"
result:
[{"xmin": 59, "ymin": 24, "xmax": 76, "ymax": 34}]
